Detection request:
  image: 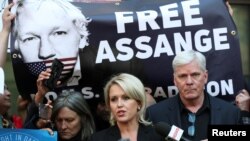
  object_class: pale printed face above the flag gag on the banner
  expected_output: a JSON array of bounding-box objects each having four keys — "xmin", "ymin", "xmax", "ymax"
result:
[{"xmin": 17, "ymin": 6, "xmax": 80, "ymax": 63}]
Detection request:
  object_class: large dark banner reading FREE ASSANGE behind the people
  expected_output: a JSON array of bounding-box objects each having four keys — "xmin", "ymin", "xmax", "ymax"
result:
[{"xmin": 11, "ymin": 0, "xmax": 244, "ymax": 105}]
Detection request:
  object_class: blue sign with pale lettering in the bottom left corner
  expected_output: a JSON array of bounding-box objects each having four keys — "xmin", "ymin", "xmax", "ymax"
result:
[{"xmin": 0, "ymin": 128, "xmax": 57, "ymax": 141}]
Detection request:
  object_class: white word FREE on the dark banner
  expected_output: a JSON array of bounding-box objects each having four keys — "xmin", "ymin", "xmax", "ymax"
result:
[{"xmin": 115, "ymin": 0, "xmax": 203, "ymax": 34}]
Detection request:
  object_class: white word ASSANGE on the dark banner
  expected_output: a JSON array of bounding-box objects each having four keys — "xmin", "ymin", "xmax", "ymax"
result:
[{"xmin": 96, "ymin": 27, "xmax": 230, "ymax": 64}]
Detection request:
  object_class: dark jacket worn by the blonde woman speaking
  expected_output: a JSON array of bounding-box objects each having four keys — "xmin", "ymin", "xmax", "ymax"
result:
[{"xmin": 90, "ymin": 124, "xmax": 164, "ymax": 141}]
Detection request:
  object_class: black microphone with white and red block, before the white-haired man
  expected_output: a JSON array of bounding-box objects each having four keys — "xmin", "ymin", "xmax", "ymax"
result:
[{"xmin": 154, "ymin": 122, "xmax": 191, "ymax": 141}]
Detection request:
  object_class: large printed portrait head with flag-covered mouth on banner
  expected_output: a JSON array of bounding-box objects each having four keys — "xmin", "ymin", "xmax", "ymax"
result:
[{"xmin": 12, "ymin": 0, "xmax": 90, "ymax": 86}]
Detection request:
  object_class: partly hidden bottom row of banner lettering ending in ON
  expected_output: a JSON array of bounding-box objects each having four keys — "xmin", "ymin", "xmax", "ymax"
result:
[{"xmin": 82, "ymin": 79, "xmax": 234, "ymax": 99}]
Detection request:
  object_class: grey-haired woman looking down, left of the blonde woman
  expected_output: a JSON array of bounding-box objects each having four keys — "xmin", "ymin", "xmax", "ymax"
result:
[{"xmin": 47, "ymin": 91, "xmax": 95, "ymax": 141}]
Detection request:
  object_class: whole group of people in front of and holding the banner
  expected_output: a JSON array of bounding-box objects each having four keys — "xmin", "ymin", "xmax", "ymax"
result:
[{"xmin": 0, "ymin": 0, "xmax": 250, "ymax": 141}]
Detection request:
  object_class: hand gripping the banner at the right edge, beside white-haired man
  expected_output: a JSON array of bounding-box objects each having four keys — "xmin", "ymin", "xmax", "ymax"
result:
[{"xmin": 235, "ymin": 89, "xmax": 250, "ymax": 124}]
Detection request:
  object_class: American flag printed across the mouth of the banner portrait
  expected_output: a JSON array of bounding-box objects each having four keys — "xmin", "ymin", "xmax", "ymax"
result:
[{"xmin": 26, "ymin": 57, "xmax": 77, "ymax": 78}]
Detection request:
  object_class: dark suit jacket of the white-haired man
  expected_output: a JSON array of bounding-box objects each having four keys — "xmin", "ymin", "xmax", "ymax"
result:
[{"xmin": 146, "ymin": 95, "xmax": 241, "ymax": 128}]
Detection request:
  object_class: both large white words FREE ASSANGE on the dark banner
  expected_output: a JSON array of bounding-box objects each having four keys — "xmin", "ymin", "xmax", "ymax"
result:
[{"xmin": 95, "ymin": 0, "xmax": 230, "ymax": 64}]
